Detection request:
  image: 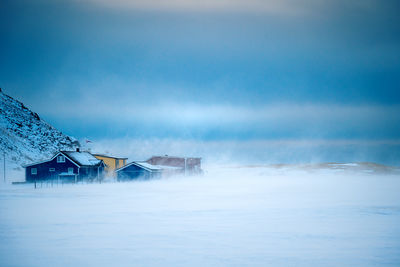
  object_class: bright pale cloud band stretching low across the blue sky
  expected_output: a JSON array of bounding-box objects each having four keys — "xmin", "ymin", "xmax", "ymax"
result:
[{"xmin": 41, "ymin": 94, "xmax": 400, "ymax": 125}]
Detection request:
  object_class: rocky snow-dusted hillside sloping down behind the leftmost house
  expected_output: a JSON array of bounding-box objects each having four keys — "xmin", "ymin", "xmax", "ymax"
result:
[{"xmin": 0, "ymin": 90, "xmax": 79, "ymax": 166}]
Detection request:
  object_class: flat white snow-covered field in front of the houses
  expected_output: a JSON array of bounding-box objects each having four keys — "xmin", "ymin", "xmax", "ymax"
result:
[{"xmin": 0, "ymin": 167, "xmax": 400, "ymax": 267}]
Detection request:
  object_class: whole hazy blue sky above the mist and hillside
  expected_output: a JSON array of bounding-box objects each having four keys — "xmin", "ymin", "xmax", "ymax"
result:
[{"xmin": 0, "ymin": 0, "xmax": 400, "ymax": 140}]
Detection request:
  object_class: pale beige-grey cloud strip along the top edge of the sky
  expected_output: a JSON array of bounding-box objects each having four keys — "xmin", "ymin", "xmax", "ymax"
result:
[{"xmin": 72, "ymin": 0, "xmax": 390, "ymax": 16}]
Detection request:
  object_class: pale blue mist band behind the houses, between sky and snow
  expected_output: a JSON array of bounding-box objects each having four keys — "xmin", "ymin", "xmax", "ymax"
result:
[{"xmin": 86, "ymin": 138, "xmax": 400, "ymax": 168}]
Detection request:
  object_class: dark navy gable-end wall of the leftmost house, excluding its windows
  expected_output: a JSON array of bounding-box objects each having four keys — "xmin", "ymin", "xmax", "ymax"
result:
[{"xmin": 25, "ymin": 157, "xmax": 78, "ymax": 182}]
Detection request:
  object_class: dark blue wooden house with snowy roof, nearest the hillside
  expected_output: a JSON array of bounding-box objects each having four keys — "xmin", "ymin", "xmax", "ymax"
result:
[{"xmin": 23, "ymin": 149, "xmax": 105, "ymax": 182}]
